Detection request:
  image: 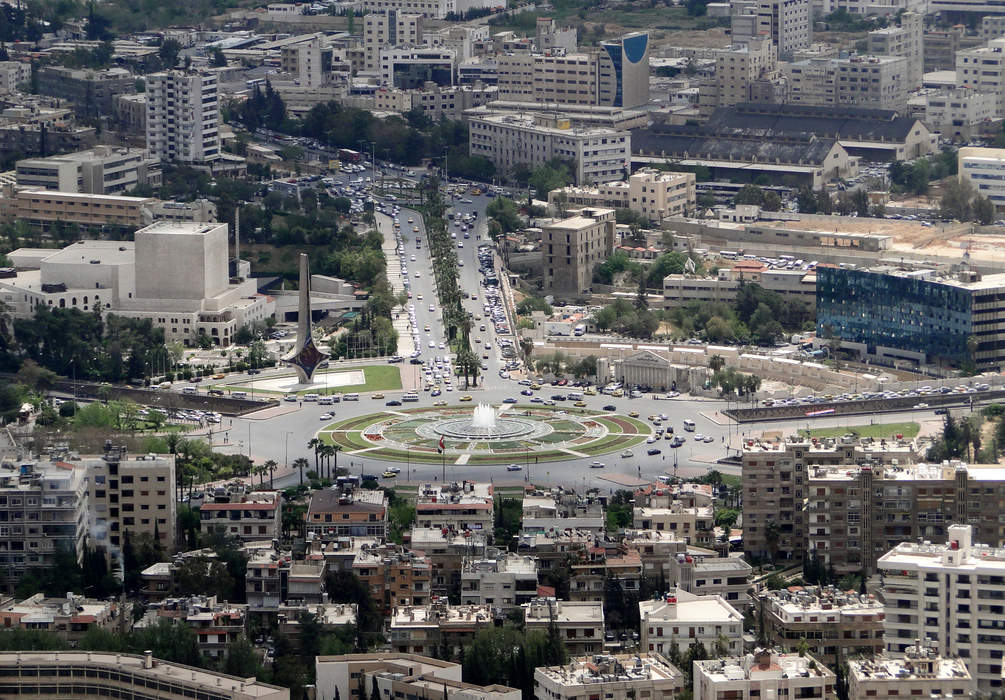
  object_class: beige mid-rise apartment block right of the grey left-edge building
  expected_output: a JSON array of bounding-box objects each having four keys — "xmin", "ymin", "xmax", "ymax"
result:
[{"xmin": 84, "ymin": 447, "xmax": 177, "ymax": 552}]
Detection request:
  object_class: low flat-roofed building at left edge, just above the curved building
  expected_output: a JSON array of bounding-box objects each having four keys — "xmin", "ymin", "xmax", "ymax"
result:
[{"xmin": 0, "ymin": 592, "xmax": 133, "ymax": 643}]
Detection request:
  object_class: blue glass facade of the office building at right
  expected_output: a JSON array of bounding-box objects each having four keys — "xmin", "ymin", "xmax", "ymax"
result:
[{"xmin": 817, "ymin": 267, "xmax": 974, "ymax": 362}]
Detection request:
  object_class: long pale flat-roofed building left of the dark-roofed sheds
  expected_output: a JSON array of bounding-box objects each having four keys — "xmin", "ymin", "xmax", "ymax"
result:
[{"xmin": 469, "ymin": 114, "xmax": 631, "ymax": 185}]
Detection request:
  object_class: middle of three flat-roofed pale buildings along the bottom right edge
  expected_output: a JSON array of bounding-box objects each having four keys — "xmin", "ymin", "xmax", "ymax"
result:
[{"xmin": 693, "ymin": 649, "xmax": 837, "ymax": 700}]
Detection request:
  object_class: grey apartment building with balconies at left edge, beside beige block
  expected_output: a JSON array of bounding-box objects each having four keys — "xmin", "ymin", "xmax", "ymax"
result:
[{"xmin": 0, "ymin": 461, "xmax": 90, "ymax": 593}]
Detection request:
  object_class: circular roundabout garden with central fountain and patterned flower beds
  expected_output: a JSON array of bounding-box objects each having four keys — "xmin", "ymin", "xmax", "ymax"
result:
[{"xmin": 319, "ymin": 405, "xmax": 650, "ymax": 465}]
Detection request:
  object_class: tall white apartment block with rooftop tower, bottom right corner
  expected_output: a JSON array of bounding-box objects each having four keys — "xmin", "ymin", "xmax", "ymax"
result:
[{"xmin": 877, "ymin": 525, "xmax": 1005, "ymax": 695}]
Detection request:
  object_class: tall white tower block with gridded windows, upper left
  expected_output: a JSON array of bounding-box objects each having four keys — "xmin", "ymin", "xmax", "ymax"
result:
[{"xmin": 147, "ymin": 70, "xmax": 220, "ymax": 164}]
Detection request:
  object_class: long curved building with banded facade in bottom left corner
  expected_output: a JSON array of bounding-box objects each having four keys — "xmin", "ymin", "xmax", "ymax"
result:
[{"xmin": 0, "ymin": 651, "xmax": 289, "ymax": 700}]
